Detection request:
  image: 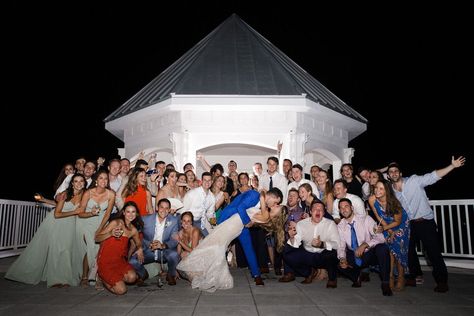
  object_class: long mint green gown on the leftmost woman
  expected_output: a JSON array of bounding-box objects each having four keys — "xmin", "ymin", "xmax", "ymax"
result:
[{"xmin": 5, "ymin": 202, "xmax": 79, "ymax": 287}]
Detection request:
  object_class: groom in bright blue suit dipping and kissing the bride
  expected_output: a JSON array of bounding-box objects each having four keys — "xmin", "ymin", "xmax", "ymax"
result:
[{"xmin": 218, "ymin": 188, "xmax": 283, "ymax": 285}]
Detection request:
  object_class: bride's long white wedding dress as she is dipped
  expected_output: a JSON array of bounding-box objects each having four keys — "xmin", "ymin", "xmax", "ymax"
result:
[{"xmin": 176, "ymin": 207, "xmax": 260, "ymax": 292}]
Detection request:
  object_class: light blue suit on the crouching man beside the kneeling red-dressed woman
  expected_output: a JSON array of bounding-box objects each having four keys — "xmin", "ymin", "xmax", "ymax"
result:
[{"xmin": 129, "ymin": 214, "xmax": 179, "ymax": 278}]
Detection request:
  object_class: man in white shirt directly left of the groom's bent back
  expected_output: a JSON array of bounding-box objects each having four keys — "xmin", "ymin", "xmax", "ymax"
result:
[{"xmin": 178, "ymin": 172, "xmax": 216, "ymax": 236}]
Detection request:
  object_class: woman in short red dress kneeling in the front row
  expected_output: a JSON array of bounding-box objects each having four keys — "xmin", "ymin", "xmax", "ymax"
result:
[{"xmin": 95, "ymin": 201, "xmax": 143, "ymax": 295}]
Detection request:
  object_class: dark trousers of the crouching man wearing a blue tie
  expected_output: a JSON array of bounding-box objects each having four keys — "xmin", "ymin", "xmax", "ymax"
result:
[{"xmin": 338, "ymin": 244, "xmax": 390, "ymax": 283}]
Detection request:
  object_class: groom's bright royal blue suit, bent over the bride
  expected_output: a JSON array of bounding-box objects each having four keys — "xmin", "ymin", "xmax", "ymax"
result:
[{"xmin": 218, "ymin": 190, "xmax": 260, "ymax": 277}]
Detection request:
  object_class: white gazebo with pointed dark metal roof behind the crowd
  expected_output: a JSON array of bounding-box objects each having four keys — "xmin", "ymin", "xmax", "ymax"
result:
[{"xmin": 105, "ymin": 14, "xmax": 367, "ymax": 178}]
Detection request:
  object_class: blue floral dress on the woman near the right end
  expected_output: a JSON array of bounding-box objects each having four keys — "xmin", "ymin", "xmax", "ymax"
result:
[{"xmin": 374, "ymin": 200, "xmax": 410, "ymax": 269}]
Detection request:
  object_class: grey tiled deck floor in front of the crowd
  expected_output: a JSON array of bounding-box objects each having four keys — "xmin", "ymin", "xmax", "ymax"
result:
[{"xmin": 0, "ymin": 258, "xmax": 474, "ymax": 316}]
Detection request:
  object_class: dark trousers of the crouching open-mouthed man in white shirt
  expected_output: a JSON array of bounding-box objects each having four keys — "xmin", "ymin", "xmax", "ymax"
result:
[{"xmin": 283, "ymin": 245, "xmax": 338, "ymax": 281}]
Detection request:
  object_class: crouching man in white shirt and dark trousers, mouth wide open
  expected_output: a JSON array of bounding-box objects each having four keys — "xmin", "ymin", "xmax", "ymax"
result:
[{"xmin": 278, "ymin": 200, "xmax": 339, "ymax": 288}]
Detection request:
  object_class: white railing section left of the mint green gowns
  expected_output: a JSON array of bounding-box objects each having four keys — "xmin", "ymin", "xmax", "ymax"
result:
[{"xmin": 0, "ymin": 199, "xmax": 51, "ymax": 258}]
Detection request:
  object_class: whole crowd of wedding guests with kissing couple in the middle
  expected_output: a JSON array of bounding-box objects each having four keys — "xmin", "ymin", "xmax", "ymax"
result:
[{"xmin": 5, "ymin": 152, "xmax": 465, "ymax": 296}]
